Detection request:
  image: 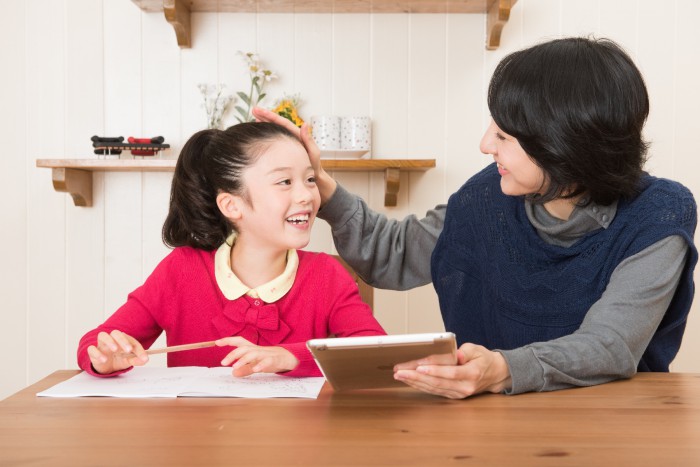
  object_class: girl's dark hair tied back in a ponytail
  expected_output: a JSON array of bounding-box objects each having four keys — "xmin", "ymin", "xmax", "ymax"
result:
[{"xmin": 163, "ymin": 122, "xmax": 301, "ymax": 250}]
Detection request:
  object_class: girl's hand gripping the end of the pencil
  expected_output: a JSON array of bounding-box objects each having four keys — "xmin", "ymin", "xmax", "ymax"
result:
[{"xmin": 88, "ymin": 329, "xmax": 148, "ymax": 375}]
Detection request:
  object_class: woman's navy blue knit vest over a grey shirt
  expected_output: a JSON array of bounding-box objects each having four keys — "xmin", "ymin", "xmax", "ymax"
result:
[{"xmin": 431, "ymin": 164, "xmax": 698, "ymax": 371}]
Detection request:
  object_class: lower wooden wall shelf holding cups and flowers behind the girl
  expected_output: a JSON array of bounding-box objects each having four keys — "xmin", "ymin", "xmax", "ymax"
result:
[{"xmin": 36, "ymin": 159, "xmax": 435, "ymax": 207}]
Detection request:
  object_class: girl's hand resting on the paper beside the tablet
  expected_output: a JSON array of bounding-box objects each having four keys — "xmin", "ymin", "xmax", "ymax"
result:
[{"xmin": 216, "ymin": 337, "xmax": 299, "ymax": 377}]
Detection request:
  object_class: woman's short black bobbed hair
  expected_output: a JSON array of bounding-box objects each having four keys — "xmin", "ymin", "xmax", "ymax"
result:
[{"xmin": 488, "ymin": 38, "xmax": 649, "ymax": 205}]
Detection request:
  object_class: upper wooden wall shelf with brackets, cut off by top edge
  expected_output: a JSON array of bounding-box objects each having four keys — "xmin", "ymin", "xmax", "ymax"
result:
[{"xmin": 131, "ymin": 0, "xmax": 518, "ymax": 50}]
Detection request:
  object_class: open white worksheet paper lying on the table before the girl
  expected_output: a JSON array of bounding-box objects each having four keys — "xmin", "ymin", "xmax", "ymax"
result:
[{"xmin": 37, "ymin": 366, "xmax": 325, "ymax": 399}]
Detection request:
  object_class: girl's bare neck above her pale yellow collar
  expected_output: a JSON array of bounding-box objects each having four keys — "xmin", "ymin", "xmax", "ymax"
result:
[{"xmin": 231, "ymin": 238, "xmax": 287, "ymax": 289}]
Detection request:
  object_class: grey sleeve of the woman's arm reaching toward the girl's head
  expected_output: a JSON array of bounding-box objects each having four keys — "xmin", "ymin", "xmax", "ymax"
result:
[{"xmin": 318, "ymin": 185, "xmax": 446, "ymax": 290}]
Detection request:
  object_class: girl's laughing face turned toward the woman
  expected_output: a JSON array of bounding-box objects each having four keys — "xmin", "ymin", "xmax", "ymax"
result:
[{"xmin": 235, "ymin": 138, "xmax": 321, "ymax": 252}]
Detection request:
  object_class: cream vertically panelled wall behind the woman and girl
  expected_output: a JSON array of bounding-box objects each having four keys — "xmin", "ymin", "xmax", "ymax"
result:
[{"xmin": 0, "ymin": 0, "xmax": 700, "ymax": 397}]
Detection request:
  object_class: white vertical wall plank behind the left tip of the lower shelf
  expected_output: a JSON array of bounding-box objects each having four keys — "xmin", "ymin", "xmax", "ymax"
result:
[{"xmin": 26, "ymin": 0, "xmax": 67, "ymax": 381}]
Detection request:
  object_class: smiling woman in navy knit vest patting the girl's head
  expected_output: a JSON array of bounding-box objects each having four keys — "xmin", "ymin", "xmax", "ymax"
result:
[{"xmin": 254, "ymin": 38, "xmax": 697, "ymax": 398}]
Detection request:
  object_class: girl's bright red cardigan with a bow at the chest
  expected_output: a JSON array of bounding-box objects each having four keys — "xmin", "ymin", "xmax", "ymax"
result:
[{"xmin": 78, "ymin": 247, "xmax": 386, "ymax": 376}]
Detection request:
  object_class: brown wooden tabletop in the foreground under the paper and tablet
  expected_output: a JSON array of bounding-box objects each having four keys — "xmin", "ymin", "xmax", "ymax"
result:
[{"xmin": 0, "ymin": 371, "xmax": 700, "ymax": 467}]
